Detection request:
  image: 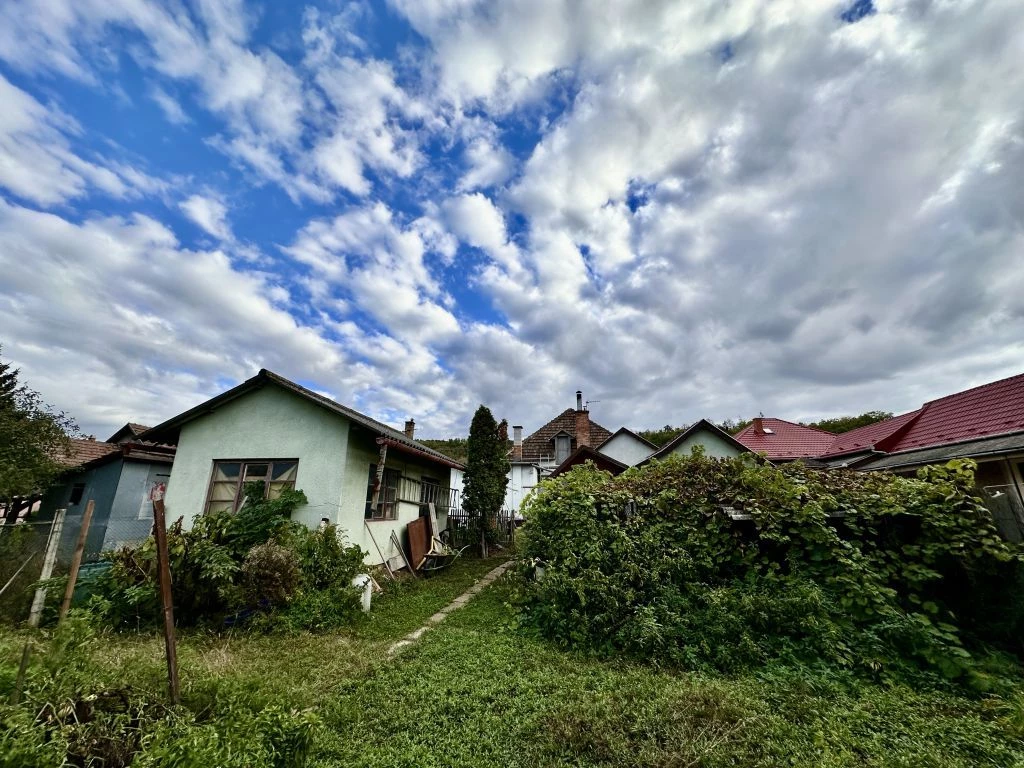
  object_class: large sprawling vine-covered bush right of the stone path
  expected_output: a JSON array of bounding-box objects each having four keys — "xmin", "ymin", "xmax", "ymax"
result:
[{"xmin": 518, "ymin": 453, "xmax": 1018, "ymax": 677}]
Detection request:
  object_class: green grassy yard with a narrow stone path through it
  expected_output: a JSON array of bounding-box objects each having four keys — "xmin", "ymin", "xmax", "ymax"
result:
[{"xmin": 0, "ymin": 559, "xmax": 1024, "ymax": 768}]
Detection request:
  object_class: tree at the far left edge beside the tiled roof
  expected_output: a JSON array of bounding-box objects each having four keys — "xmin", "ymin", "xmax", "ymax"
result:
[{"xmin": 0, "ymin": 348, "xmax": 78, "ymax": 509}]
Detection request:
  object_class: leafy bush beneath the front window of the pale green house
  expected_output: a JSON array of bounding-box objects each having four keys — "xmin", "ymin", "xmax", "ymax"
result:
[{"xmin": 88, "ymin": 484, "xmax": 364, "ymax": 629}]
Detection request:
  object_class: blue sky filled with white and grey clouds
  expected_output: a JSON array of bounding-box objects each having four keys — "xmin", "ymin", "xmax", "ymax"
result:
[{"xmin": 0, "ymin": 0, "xmax": 1024, "ymax": 438}]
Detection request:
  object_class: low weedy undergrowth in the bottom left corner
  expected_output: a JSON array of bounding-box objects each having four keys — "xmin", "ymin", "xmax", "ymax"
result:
[{"xmin": 0, "ymin": 620, "xmax": 317, "ymax": 768}]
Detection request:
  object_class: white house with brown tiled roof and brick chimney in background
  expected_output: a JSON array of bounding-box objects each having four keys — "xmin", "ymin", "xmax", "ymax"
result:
[{"xmin": 505, "ymin": 391, "xmax": 611, "ymax": 510}]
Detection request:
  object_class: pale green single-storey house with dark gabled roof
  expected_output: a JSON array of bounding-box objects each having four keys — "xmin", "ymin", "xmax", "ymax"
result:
[{"xmin": 143, "ymin": 370, "xmax": 464, "ymax": 564}]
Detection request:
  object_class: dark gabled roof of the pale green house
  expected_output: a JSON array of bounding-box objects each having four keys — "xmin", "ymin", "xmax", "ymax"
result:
[{"xmin": 141, "ymin": 368, "xmax": 465, "ymax": 469}]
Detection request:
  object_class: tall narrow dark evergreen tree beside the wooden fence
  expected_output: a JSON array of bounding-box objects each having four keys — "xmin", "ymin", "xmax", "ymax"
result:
[{"xmin": 463, "ymin": 406, "xmax": 509, "ymax": 557}]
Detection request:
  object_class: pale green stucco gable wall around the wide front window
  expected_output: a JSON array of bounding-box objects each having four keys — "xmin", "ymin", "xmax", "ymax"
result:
[{"xmin": 166, "ymin": 385, "xmax": 348, "ymax": 526}]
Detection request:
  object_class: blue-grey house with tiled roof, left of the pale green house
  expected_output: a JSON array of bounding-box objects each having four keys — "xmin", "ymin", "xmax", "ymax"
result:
[{"xmin": 39, "ymin": 425, "xmax": 174, "ymax": 560}]
